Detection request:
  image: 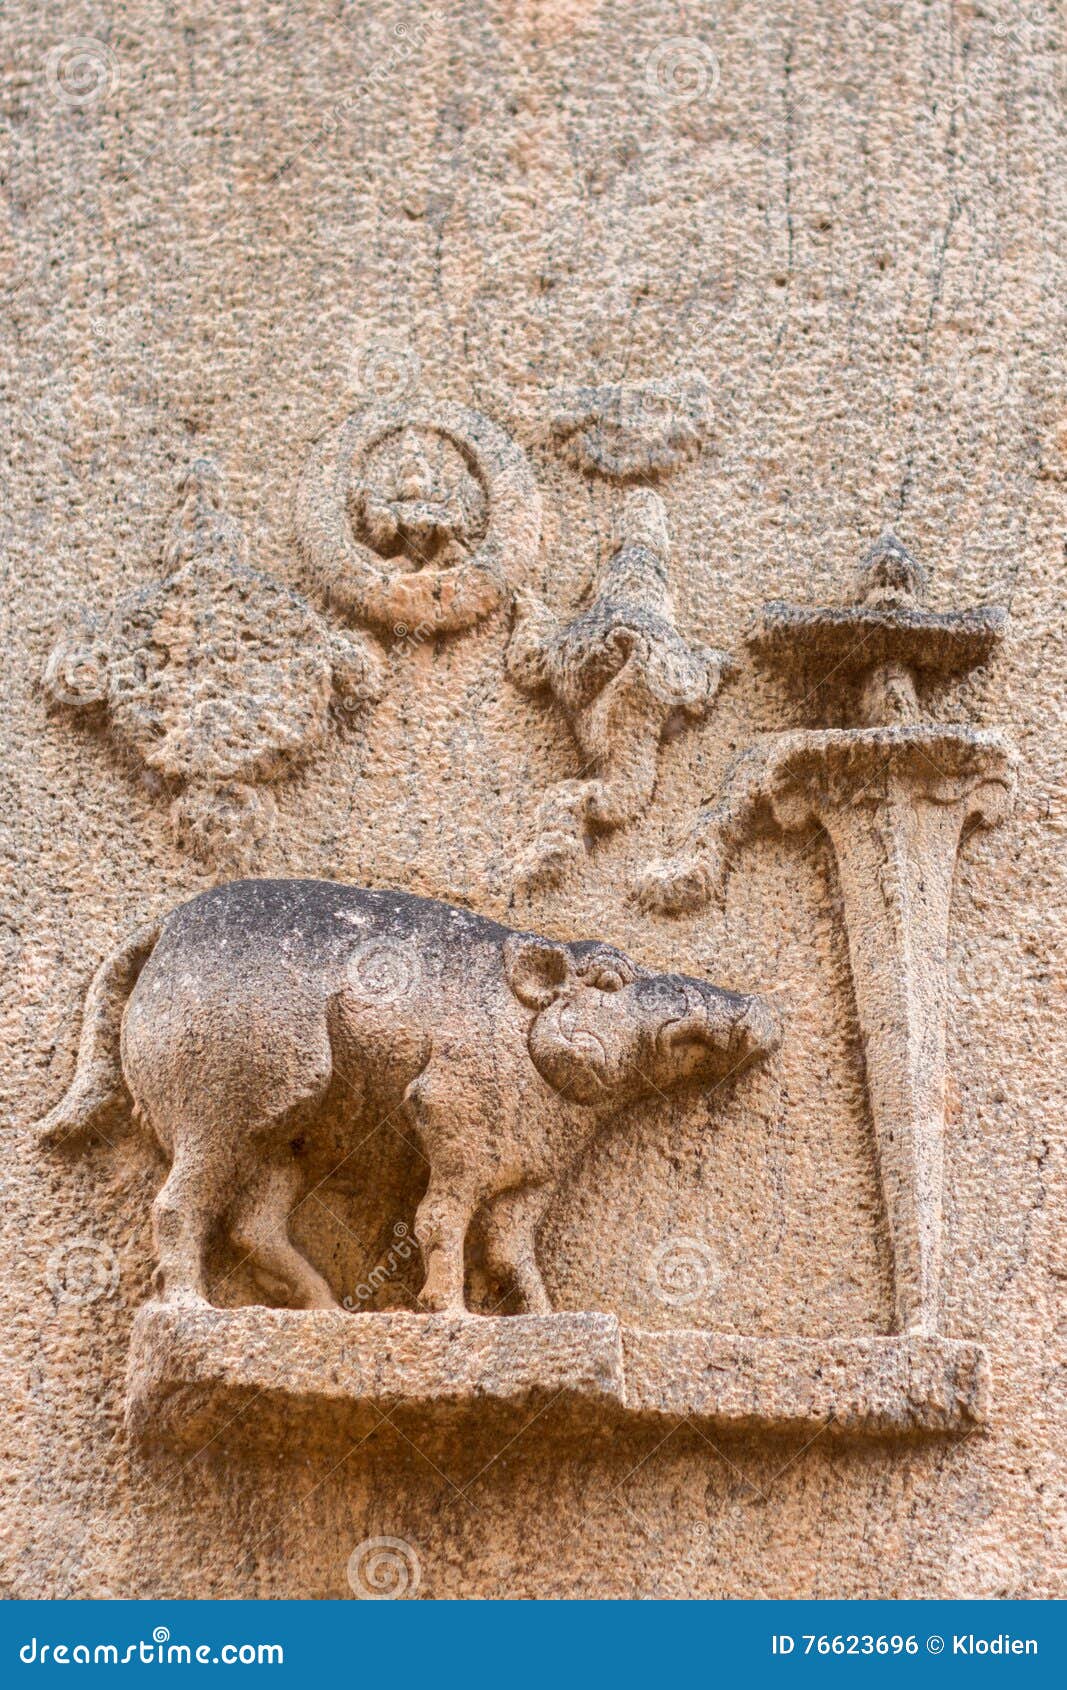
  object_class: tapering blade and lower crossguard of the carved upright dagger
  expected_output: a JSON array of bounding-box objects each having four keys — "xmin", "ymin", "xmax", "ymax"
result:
[{"xmin": 744, "ymin": 727, "xmax": 1013, "ymax": 1333}]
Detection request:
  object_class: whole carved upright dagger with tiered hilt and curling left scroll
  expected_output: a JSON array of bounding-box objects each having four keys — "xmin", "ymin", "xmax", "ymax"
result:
[{"xmin": 641, "ymin": 534, "xmax": 1015, "ymax": 1333}]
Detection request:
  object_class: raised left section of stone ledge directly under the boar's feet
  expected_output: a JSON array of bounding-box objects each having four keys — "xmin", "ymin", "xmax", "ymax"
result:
[{"xmin": 127, "ymin": 1303, "xmax": 624, "ymax": 1445}]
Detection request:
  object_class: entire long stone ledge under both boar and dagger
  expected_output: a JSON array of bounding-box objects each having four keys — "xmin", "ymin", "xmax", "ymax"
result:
[{"xmin": 127, "ymin": 1303, "xmax": 989, "ymax": 1448}]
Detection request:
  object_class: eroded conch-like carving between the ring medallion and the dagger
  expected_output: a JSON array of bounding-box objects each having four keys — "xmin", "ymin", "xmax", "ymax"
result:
[{"xmin": 507, "ymin": 488, "xmax": 727, "ymax": 887}]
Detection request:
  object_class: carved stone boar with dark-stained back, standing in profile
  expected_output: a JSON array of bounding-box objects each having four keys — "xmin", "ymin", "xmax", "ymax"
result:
[{"xmin": 39, "ymin": 880, "xmax": 778, "ymax": 1313}]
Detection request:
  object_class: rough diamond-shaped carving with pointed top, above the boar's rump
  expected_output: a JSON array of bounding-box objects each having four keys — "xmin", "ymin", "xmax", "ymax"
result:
[{"xmin": 44, "ymin": 458, "xmax": 380, "ymax": 870}]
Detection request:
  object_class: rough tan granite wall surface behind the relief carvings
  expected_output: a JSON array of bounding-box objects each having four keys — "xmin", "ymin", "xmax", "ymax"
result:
[{"xmin": 0, "ymin": 0, "xmax": 1067, "ymax": 1597}]
